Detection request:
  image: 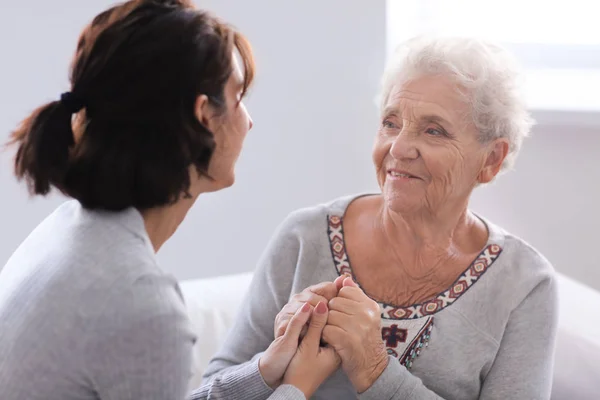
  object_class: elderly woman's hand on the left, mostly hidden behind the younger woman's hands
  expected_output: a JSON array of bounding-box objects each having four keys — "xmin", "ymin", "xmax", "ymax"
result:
[{"xmin": 274, "ymin": 276, "xmax": 344, "ymax": 338}]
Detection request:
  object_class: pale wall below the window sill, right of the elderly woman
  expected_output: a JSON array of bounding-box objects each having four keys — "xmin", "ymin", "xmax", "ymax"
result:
[{"xmin": 471, "ymin": 119, "xmax": 600, "ymax": 290}]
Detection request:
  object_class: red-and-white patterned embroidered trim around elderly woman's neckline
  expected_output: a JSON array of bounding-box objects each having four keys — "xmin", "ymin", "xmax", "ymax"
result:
[{"xmin": 327, "ymin": 215, "xmax": 502, "ymax": 320}]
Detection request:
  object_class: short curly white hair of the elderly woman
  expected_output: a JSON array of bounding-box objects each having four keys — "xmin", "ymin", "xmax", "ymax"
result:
[{"xmin": 380, "ymin": 36, "xmax": 534, "ymax": 171}]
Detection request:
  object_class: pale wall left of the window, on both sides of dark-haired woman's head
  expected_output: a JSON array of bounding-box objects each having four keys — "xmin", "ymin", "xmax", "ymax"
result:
[{"xmin": 0, "ymin": 0, "xmax": 385, "ymax": 278}]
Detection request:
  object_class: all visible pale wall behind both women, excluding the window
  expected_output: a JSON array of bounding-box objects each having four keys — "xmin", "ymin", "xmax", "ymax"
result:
[{"xmin": 0, "ymin": 0, "xmax": 600, "ymax": 289}]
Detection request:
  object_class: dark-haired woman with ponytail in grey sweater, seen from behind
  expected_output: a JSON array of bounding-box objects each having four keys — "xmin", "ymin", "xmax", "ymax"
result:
[{"xmin": 0, "ymin": 0, "xmax": 339, "ymax": 400}]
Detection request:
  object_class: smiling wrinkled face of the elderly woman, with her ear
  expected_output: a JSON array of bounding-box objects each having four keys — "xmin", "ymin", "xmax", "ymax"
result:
[{"xmin": 373, "ymin": 76, "xmax": 505, "ymax": 214}]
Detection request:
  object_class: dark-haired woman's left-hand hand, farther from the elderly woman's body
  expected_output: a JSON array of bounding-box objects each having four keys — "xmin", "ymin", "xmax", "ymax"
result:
[{"xmin": 258, "ymin": 303, "xmax": 313, "ymax": 389}]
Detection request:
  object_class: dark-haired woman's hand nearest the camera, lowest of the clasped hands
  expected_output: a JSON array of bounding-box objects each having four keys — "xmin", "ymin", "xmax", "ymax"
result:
[{"xmin": 283, "ymin": 302, "xmax": 340, "ymax": 399}]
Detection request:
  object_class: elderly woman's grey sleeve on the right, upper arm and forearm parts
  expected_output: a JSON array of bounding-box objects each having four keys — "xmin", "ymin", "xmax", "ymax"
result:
[{"xmin": 359, "ymin": 277, "xmax": 558, "ymax": 400}]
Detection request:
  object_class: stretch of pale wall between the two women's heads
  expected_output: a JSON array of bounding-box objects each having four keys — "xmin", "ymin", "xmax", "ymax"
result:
[{"xmin": 160, "ymin": 0, "xmax": 385, "ymax": 277}]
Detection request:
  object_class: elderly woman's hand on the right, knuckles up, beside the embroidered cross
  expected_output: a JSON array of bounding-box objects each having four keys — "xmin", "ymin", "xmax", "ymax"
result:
[{"xmin": 323, "ymin": 278, "xmax": 388, "ymax": 393}]
